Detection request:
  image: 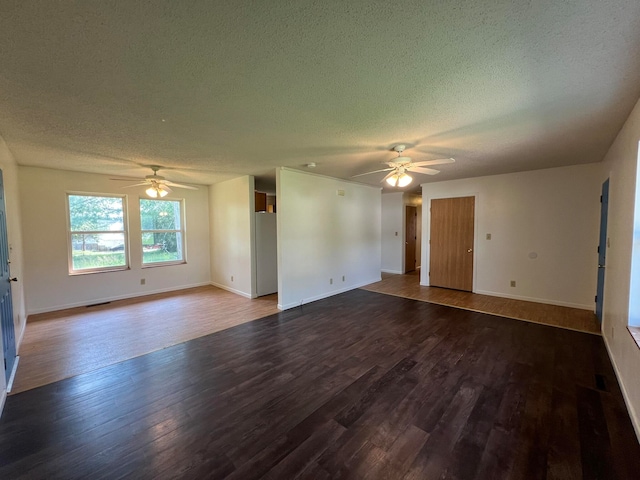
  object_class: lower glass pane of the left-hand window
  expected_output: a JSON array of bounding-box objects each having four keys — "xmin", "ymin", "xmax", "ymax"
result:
[{"xmin": 71, "ymin": 233, "xmax": 127, "ymax": 270}]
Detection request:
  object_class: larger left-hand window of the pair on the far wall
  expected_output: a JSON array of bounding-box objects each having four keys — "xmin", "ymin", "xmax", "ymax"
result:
[{"xmin": 67, "ymin": 193, "xmax": 129, "ymax": 275}]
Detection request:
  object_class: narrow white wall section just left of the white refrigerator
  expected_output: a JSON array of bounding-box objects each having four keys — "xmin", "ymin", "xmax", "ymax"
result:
[{"xmin": 209, "ymin": 176, "xmax": 256, "ymax": 298}]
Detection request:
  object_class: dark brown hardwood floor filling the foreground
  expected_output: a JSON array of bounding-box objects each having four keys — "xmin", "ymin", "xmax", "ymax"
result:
[{"xmin": 0, "ymin": 290, "xmax": 640, "ymax": 479}]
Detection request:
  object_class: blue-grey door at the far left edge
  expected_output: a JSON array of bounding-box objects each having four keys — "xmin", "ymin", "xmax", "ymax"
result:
[{"xmin": 0, "ymin": 170, "xmax": 16, "ymax": 382}]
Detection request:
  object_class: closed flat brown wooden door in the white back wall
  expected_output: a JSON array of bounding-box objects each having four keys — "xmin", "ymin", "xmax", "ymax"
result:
[{"xmin": 429, "ymin": 197, "xmax": 475, "ymax": 292}]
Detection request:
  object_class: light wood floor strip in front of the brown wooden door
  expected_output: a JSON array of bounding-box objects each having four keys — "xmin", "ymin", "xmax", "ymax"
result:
[{"xmin": 363, "ymin": 272, "xmax": 600, "ymax": 335}]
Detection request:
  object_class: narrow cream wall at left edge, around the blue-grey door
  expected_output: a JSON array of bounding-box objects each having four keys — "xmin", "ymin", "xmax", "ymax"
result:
[{"xmin": 0, "ymin": 137, "xmax": 27, "ymax": 412}]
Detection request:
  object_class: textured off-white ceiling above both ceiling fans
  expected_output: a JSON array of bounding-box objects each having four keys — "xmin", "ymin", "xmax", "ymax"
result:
[{"xmin": 0, "ymin": 0, "xmax": 640, "ymax": 193}]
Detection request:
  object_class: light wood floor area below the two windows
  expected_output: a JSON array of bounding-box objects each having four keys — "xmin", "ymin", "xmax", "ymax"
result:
[{"xmin": 11, "ymin": 286, "xmax": 279, "ymax": 394}]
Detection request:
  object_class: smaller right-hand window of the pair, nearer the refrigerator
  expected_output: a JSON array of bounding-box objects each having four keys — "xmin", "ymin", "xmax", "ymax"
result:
[{"xmin": 140, "ymin": 198, "xmax": 185, "ymax": 266}]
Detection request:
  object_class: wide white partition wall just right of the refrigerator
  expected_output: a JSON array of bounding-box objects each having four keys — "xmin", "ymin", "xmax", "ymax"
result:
[{"xmin": 276, "ymin": 168, "xmax": 382, "ymax": 309}]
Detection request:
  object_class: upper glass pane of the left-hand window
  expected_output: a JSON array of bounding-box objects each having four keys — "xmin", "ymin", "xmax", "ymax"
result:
[{"xmin": 69, "ymin": 195, "xmax": 124, "ymax": 232}]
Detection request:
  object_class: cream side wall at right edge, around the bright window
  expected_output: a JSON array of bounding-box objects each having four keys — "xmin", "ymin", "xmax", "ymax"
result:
[{"xmin": 600, "ymin": 95, "xmax": 640, "ymax": 438}]
